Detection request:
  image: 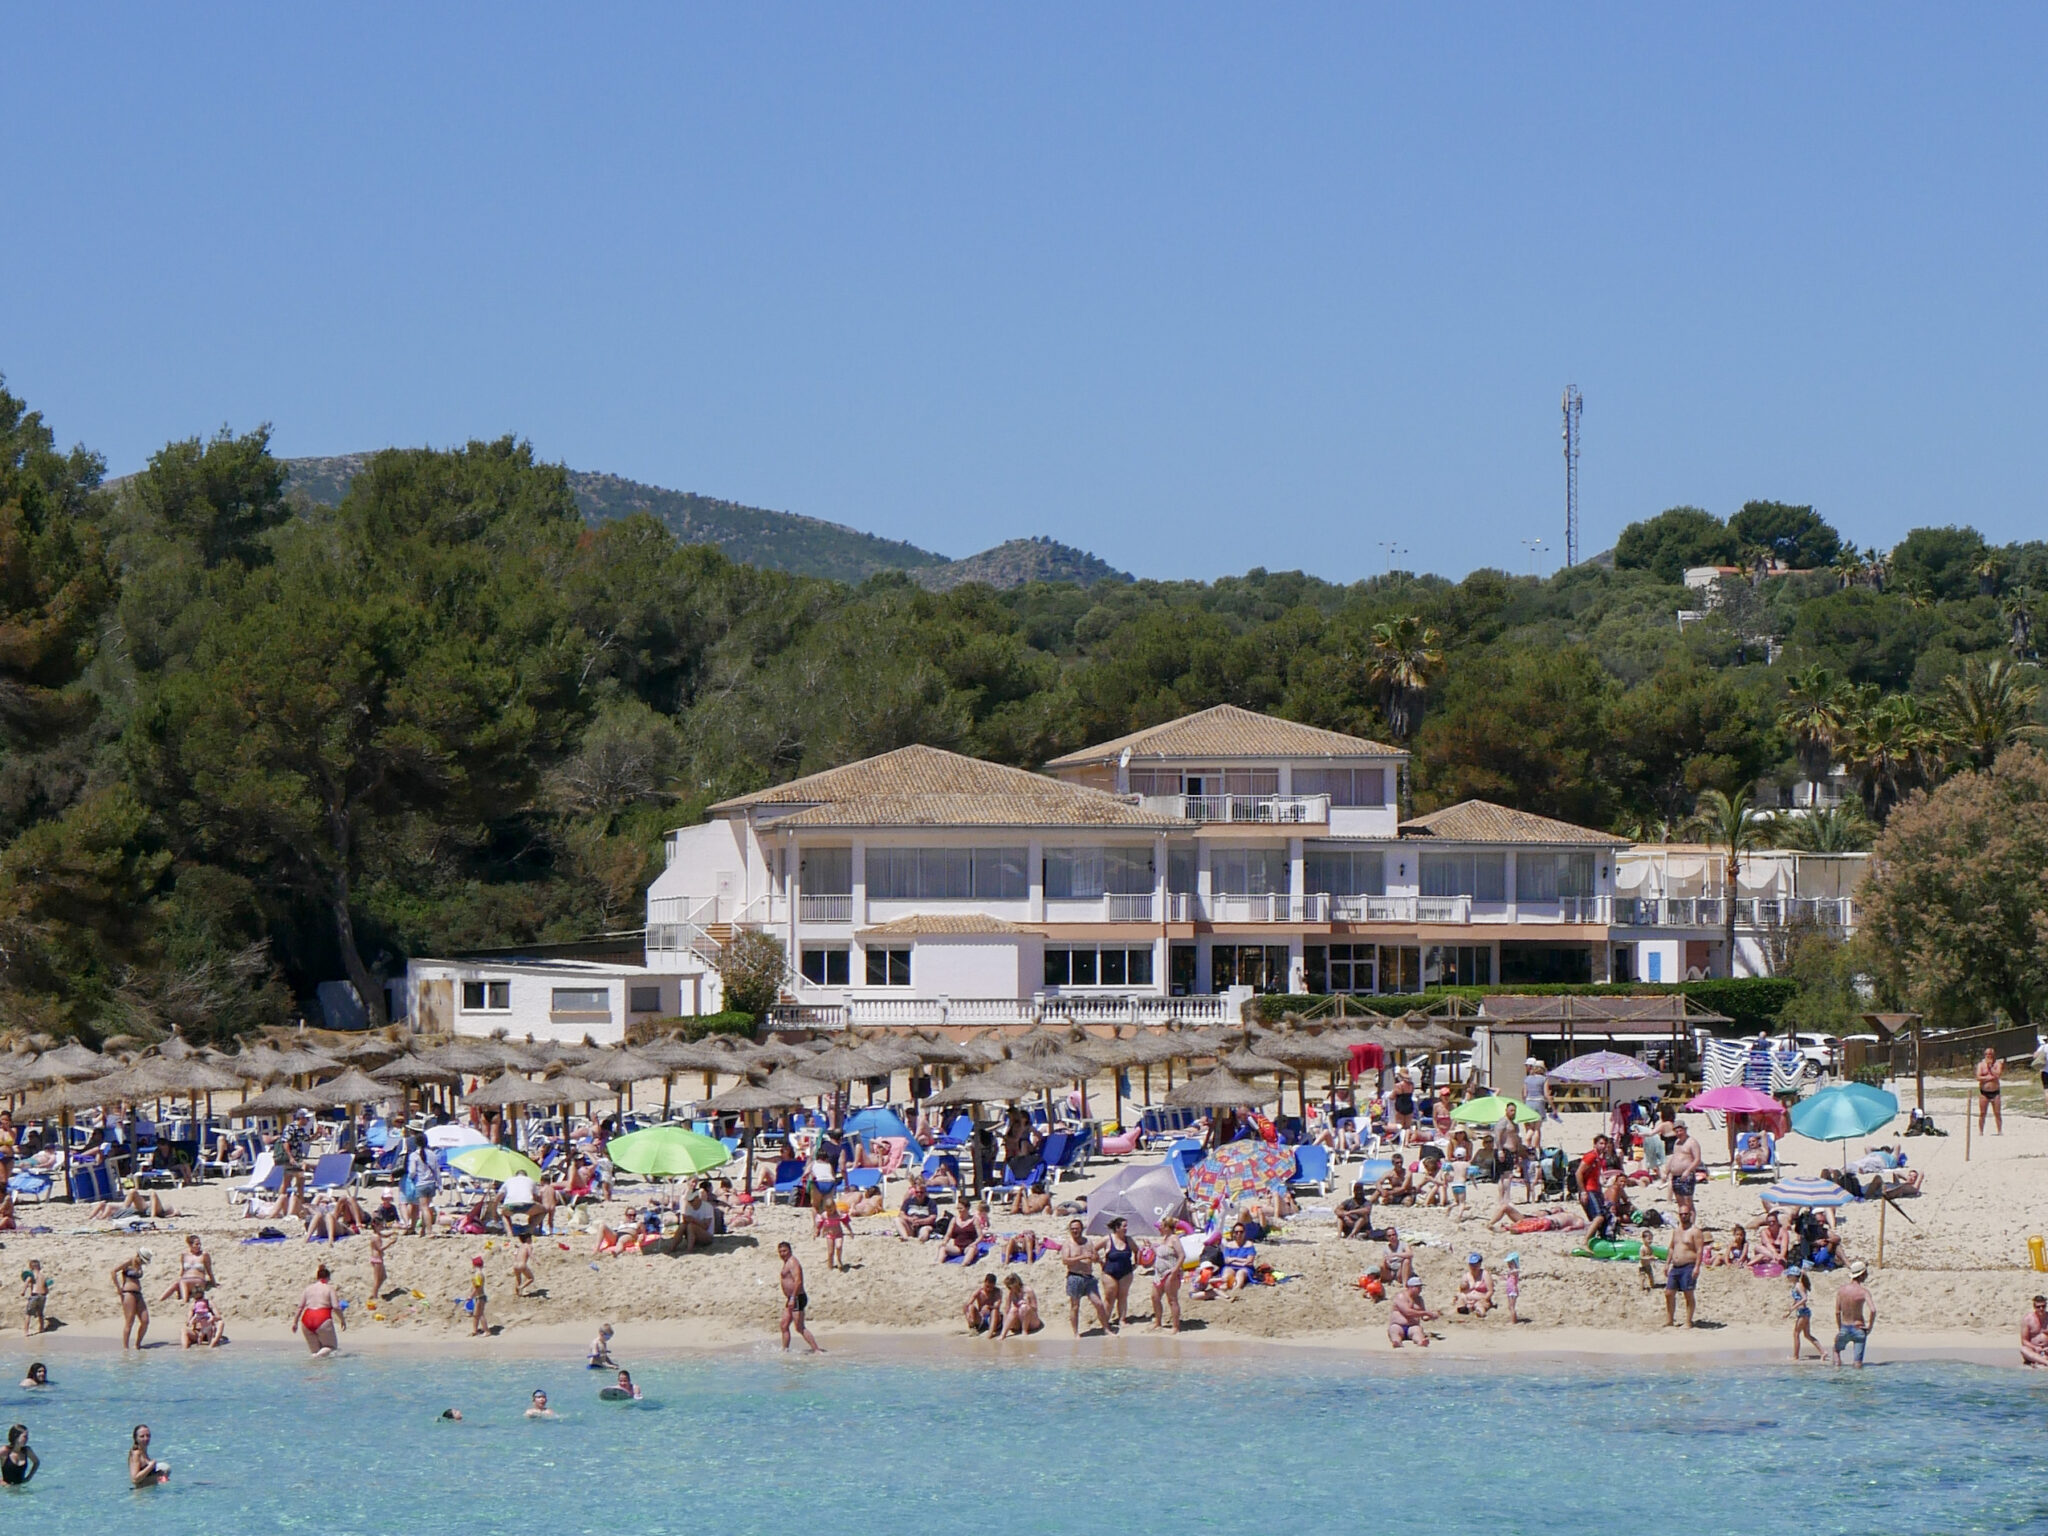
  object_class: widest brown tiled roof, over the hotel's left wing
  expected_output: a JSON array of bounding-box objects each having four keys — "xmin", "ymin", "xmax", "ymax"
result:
[{"xmin": 711, "ymin": 745, "xmax": 1186, "ymax": 831}]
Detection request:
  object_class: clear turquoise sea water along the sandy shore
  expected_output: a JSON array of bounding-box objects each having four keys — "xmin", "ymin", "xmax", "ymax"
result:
[{"xmin": 0, "ymin": 1350, "xmax": 2048, "ymax": 1536}]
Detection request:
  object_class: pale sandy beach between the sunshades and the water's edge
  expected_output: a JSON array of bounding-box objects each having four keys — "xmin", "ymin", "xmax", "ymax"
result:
[{"xmin": 0, "ymin": 1081, "xmax": 2048, "ymax": 1364}]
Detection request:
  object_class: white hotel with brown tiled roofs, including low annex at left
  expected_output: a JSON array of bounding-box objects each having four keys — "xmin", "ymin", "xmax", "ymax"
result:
[{"xmin": 410, "ymin": 705, "xmax": 1862, "ymax": 1040}]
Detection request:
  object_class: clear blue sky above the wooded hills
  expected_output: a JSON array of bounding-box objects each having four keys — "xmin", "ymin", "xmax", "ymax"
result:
[{"xmin": 0, "ymin": 4, "xmax": 2048, "ymax": 580}]
